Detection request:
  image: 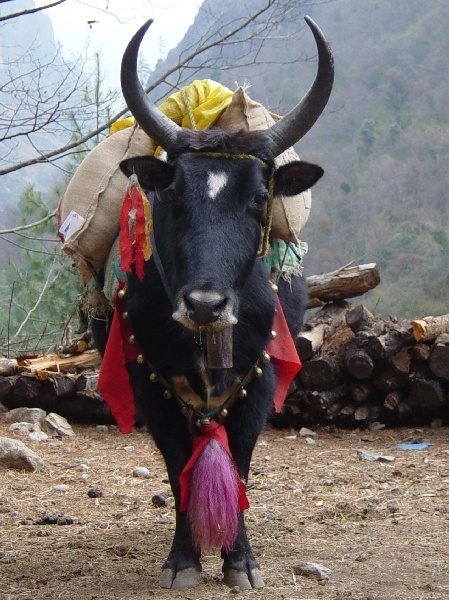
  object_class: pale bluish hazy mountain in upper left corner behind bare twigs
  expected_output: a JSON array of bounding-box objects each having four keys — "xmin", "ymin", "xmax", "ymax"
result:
[{"xmin": 0, "ymin": 0, "xmax": 61, "ymax": 211}]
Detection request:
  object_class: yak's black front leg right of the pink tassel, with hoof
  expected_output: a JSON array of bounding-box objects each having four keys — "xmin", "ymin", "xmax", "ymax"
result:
[{"xmin": 221, "ymin": 372, "xmax": 274, "ymax": 589}]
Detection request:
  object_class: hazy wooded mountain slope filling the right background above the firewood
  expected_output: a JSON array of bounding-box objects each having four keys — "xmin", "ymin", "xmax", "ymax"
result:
[{"xmin": 151, "ymin": 0, "xmax": 449, "ymax": 317}]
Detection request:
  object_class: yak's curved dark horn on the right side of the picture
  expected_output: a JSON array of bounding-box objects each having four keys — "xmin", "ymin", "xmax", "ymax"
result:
[{"xmin": 266, "ymin": 17, "xmax": 334, "ymax": 156}]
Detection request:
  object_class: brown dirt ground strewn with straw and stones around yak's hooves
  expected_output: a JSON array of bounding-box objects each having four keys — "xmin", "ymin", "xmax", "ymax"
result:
[{"xmin": 0, "ymin": 423, "xmax": 449, "ymax": 600}]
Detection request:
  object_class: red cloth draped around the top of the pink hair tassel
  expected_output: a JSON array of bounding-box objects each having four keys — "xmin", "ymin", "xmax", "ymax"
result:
[{"xmin": 179, "ymin": 421, "xmax": 249, "ymax": 512}]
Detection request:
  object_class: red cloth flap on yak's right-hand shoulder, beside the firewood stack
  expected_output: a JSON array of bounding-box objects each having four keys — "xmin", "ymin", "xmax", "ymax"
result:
[{"xmin": 267, "ymin": 298, "xmax": 302, "ymax": 412}]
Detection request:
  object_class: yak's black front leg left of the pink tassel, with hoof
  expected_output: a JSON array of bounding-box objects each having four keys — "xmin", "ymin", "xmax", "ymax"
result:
[{"xmin": 128, "ymin": 363, "xmax": 201, "ymax": 589}]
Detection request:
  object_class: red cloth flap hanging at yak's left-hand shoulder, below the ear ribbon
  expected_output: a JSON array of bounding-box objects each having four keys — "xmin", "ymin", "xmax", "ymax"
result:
[{"xmin": 98, "ymin": 283, "xmax": 140, "ymax": 433}]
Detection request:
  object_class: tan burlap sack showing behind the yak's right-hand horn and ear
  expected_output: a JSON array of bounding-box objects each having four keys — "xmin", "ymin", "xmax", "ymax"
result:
[{"xmin": 216, "ymin": 87, "xmax": 312, "ymax": 244}]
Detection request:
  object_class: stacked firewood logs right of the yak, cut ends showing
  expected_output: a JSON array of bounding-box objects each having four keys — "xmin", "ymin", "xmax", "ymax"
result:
[{"xmin": 275, "ymin": 301, "xmax": 449, "ymax": 427}]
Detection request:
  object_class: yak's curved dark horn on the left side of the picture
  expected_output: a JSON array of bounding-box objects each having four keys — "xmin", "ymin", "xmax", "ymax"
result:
[{"xmin": 120, "ymin": 19, "xmax": 181, "ymax": 150}]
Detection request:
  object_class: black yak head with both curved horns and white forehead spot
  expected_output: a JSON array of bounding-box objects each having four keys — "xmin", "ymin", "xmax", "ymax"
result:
[{"xmin": 121, "ymin": 18, "xmax": 333, "ymax": 331}]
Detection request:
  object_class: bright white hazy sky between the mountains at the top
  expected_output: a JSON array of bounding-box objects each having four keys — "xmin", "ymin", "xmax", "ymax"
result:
[{"xmin": 36, "ymin": 0, "xmax": 202, "ymax": 88}]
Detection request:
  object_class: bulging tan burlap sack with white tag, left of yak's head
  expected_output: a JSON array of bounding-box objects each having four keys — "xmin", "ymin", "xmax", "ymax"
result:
[{"xmin": 59, "ymin": 125, "xmax": 154, "ymax": 283}]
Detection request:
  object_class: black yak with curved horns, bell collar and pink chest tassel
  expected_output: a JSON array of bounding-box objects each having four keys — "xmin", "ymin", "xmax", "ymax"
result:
[{"xmin": 94, "ymin": 17, "xmax": 333, "ymax": 589}]
